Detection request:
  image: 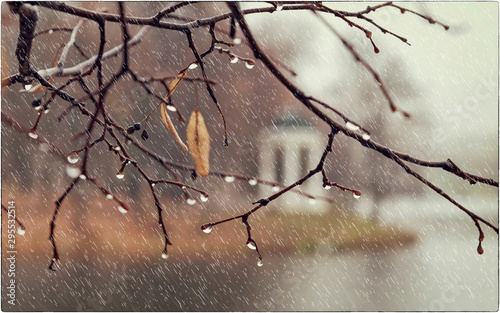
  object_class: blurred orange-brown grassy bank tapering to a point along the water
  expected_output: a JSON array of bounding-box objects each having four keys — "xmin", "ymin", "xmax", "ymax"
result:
[{"xmin": 2, "ymin": 194, "xmax": 416, "ymax": 262}]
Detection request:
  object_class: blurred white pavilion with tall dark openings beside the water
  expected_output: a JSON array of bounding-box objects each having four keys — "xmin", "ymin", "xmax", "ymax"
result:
[{"xmin": 258, "ymin": 112, "xmax": 329, "ymax": 213}]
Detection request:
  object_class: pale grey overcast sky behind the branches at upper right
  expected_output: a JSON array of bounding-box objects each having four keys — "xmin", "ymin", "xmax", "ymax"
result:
[{"xmin": 241, "ymin": 2, "xmax": 498, "ymax": 168}]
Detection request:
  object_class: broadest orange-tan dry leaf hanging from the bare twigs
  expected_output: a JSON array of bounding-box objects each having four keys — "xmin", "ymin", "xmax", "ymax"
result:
[{"xmin": 187, "ymin": 109, "xmax": 210, "ymax": 176}]
